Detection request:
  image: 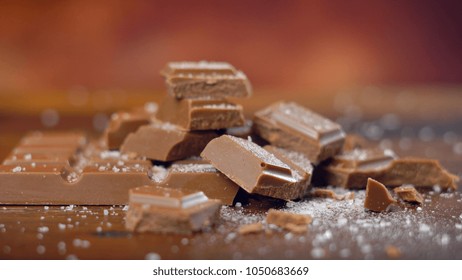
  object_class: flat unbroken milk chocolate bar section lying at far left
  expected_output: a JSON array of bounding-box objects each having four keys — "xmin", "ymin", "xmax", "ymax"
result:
[{"xmin": 0, "ymin": 133, "xmax": 157, "ymax": 205}]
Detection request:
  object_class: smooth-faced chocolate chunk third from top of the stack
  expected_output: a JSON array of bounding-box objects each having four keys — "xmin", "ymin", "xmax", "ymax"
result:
[{"xmin": 120, "ymin": 121, "xmax": 218, "ymax": 161}]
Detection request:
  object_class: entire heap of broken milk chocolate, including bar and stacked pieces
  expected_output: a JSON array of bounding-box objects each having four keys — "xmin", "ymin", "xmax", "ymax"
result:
[{"xmin": 0, "ymin": 62, "xmax": 459, "ymax": 233}]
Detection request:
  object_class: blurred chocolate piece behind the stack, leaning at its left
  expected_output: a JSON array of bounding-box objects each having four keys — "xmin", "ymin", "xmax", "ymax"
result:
[{"xmin": 103, "ymin": 103, "xmax": 157, "ymax": 150}]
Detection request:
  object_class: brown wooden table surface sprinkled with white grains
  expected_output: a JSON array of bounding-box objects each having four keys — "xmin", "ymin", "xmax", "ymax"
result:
[{"xmin": 0, "ymin": 86, "xmax": 462, "ymax": 259}]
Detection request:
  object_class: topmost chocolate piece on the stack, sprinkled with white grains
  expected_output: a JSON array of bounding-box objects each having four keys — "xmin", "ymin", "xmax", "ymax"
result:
[{"xmin": 161, "ymin": 61, "xmax": 252, "ymax": 99}]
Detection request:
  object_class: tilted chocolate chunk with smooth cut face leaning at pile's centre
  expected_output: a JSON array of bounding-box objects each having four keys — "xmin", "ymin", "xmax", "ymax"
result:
[{"xmin": 201, "ymin": 135, "xmax": 306, "ymax": 200}]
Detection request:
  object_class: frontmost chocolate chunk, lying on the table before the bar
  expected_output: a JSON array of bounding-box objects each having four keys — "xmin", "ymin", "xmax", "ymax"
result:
[{"xmin": 125, "ymin": 186, "xmax": 220, "ymax": 234}]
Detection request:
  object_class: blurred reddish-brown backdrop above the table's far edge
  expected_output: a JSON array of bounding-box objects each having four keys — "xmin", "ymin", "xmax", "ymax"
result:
[{"xmin": 0, "ymin": 0, "xmax": 462, "ymax": 92}]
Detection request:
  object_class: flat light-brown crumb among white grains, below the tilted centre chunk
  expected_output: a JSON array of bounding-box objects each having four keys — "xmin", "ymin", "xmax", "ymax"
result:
[{"xmin": 266, "ymin": 209, "xmax": 313, "ymax": 233}]
